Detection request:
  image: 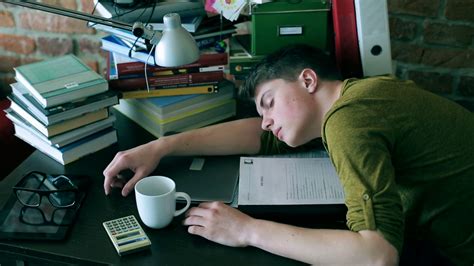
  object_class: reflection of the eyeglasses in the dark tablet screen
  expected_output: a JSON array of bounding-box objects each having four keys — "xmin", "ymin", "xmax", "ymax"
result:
[{"xmin": 20, "ymin": 206, "xmax": 76, "ymax": 226}]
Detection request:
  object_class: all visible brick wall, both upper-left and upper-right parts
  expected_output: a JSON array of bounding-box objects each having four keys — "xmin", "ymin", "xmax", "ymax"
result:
[{"xmin": 0, "ymin": 0, "xmax": 474, "ymax": 100}]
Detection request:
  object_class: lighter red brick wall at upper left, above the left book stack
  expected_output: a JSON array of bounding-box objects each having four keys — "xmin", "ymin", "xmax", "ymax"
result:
[{"xmin": 0, "ymin": 0, "xmax": 106, "ymax": 96}]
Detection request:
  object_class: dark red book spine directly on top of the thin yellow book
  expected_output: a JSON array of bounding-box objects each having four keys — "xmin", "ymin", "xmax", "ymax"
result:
[{"xmin": 109, "ymin": 71, "xmax": 224, "ymax": 91}]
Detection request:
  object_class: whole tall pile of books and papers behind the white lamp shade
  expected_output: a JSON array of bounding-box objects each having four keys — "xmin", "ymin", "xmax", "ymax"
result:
[{"xmin": 89, "ymin": 0, "xmax": 241, "ymax": 137}]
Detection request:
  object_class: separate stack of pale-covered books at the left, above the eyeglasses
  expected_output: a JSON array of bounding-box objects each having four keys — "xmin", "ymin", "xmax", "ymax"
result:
[{"xmin": 5, "ymin": 55, "xmax": 118, "ymax": 165}]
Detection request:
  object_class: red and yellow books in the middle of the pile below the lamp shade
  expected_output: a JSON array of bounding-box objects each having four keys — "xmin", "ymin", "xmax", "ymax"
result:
[{"xmin": 107, "ymin": 47, "xmax": 228, "ymax": 99}]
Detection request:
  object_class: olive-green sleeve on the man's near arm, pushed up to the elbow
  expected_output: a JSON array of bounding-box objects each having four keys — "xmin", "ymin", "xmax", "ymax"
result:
[{"xmin": 323, "ymin": 105, "xmax": 404, "ymax": 254}]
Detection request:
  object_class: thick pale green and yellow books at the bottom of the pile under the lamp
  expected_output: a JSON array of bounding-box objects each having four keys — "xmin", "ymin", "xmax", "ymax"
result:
[{"xmin": 114, "ymin": 81, "xmax": 236, "ymax": 137}]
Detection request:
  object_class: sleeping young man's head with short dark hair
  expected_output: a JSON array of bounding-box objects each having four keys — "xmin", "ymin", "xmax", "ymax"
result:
[{"xmin": 239, "ymin": 45, "xmax": 340, "ymax": 147}]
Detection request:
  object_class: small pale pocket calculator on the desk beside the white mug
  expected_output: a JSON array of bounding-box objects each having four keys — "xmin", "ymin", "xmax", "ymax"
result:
[{"xmin": 102, "ymin": 215, "xmax": 151, "ymax": 256}]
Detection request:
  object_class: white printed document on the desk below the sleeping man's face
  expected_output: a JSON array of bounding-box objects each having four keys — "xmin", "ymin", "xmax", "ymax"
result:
[{"xmin": 238, "ymin": 157, "xmax": 344, "ymax": 205}]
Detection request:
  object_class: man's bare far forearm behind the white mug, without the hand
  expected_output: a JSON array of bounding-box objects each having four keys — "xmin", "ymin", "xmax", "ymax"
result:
[{"xmin": 155, "ymin": 118, "xmax": 262, "ymax": 156}]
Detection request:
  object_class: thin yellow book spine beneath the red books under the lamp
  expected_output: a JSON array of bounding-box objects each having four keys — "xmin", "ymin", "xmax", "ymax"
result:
[{"xmin": 121, "ymin": 85, "xmax": 218, "ymax": 99}]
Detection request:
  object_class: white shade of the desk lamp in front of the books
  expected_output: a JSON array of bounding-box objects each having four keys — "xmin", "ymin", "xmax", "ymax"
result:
[{"xmin": 155, "ymin": 13, "xmax": 199, "ymax": 67}]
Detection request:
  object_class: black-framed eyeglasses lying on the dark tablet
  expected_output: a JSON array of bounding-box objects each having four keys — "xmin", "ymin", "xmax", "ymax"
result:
[{"xmin": 13, "ymin": 172, "xmax": 78, "ymax": 208}]
